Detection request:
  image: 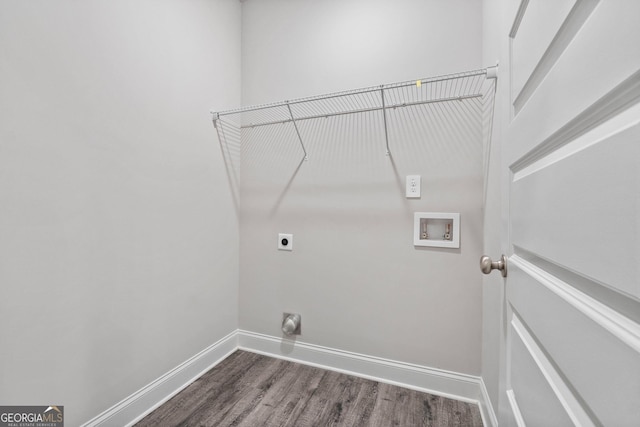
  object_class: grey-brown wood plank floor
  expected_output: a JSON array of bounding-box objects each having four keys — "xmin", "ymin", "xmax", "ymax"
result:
[{"xmin": 136, "ymin": 351, "xmax": 482, "ymax": 427}]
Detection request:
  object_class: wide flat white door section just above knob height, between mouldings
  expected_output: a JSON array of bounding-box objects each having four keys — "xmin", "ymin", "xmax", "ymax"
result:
[{"xmin": 510, "ymin": 120, "xmax": 640, "ymax": 300}]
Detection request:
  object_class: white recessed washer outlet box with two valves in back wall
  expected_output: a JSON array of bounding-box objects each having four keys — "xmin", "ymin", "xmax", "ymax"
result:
[{"xmin": 413, "ymin": 212, "xmax": 460, "ymax": 248}]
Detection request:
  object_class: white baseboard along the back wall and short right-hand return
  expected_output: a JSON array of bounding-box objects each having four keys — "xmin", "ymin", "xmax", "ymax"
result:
[{"xmin": 238, "ymin": 330, "xmax": 492, "ymax": 426}]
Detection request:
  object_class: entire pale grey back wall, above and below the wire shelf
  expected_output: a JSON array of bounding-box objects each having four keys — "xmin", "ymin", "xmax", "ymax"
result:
[{"xmin": 240, "ymin": 0, "xmax": 483, "ymax": 375}]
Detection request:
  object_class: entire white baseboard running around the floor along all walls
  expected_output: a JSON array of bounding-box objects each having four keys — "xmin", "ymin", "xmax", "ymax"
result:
[{"xmin": 82, "ymin": 330, "xmax": 498, "ymax": 427}]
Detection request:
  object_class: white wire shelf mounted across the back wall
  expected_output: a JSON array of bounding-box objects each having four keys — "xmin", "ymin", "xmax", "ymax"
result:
[{"xmin": 212, "ymin": 69, "xmax": 495, "ymax": 172}]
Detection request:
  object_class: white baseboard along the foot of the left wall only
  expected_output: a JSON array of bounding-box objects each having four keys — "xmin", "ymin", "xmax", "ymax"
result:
[{"xmin": 82, "ymin": 331, "xmax": 238, "ymax": 427}]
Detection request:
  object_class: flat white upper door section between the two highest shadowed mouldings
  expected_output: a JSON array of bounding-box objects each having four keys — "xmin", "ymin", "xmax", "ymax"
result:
[{"xmin": 507, "ymin": 0, "xmax": 640, "ymax": 164}]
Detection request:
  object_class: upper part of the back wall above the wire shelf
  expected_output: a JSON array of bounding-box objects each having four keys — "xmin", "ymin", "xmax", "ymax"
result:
[{"xmin": 242, "ymin": 0, "xmax": 482, "ymax": 105}]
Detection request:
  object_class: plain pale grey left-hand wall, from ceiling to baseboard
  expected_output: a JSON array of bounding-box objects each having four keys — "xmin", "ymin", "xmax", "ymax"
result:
[{"xmin": 0, "ymin": 0, "xmax": 241, "ymax": 426}]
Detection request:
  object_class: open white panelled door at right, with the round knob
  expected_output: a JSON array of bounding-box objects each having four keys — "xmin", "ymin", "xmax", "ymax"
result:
[{"xmin": 500, "ymin": 0, "xmax": 640, "ymax": 427}]
